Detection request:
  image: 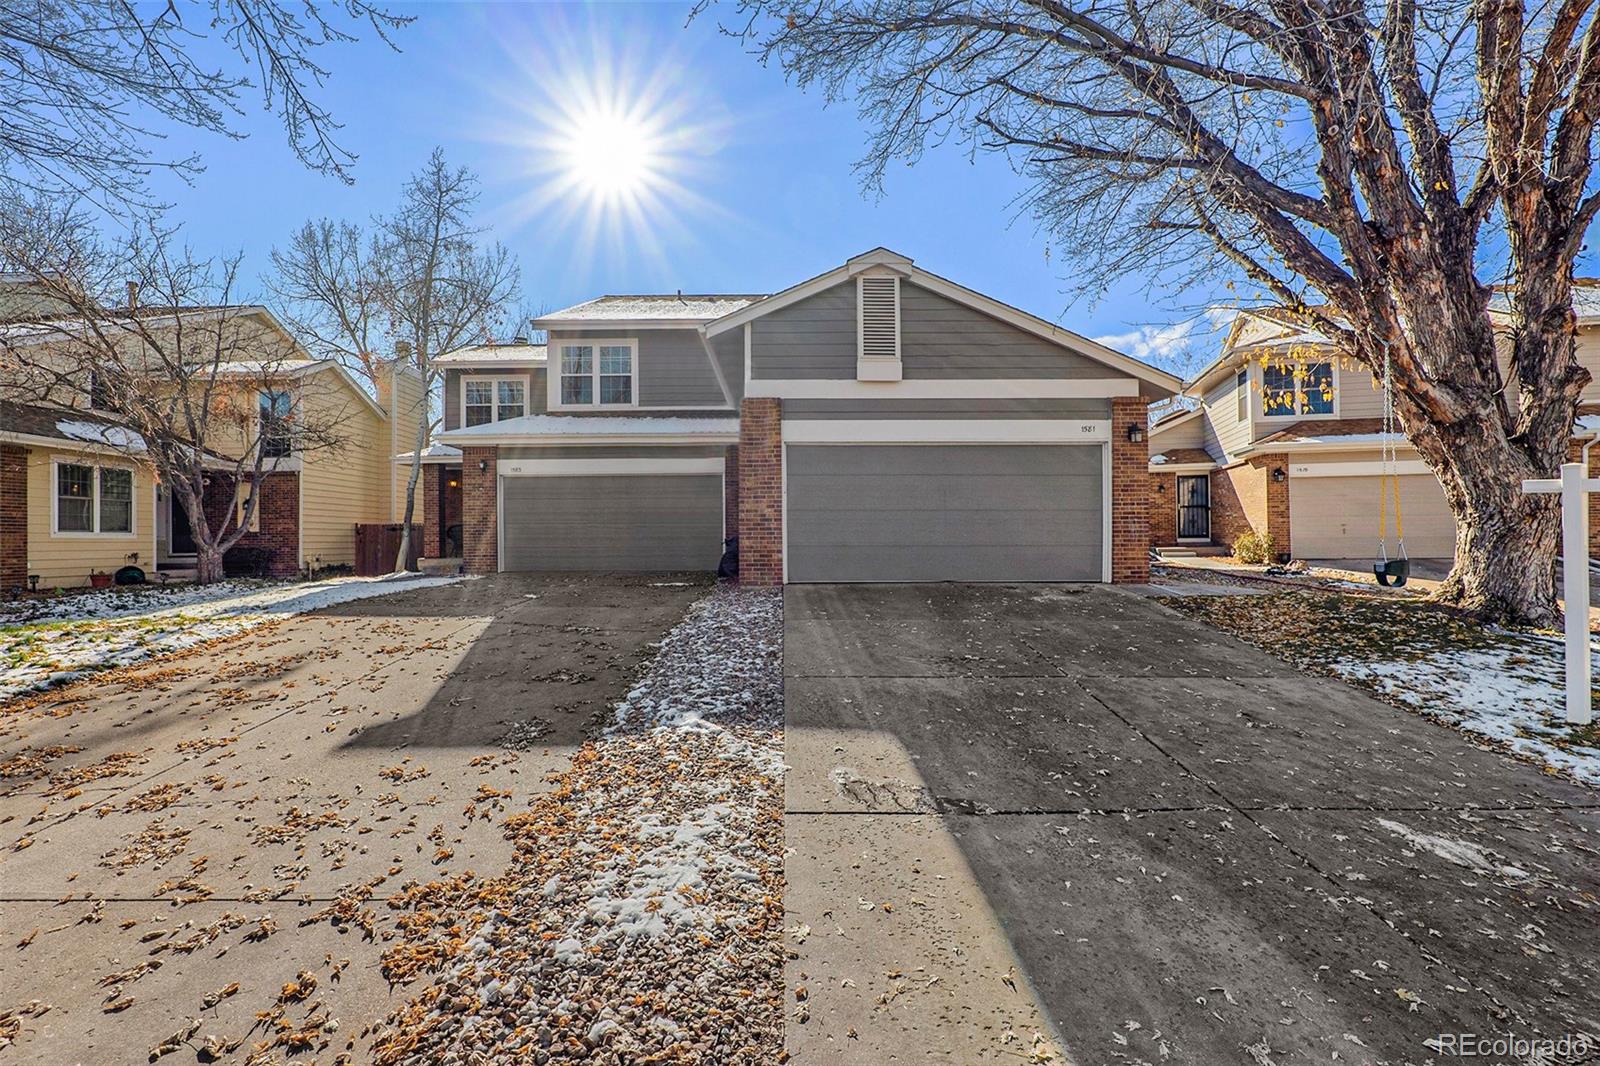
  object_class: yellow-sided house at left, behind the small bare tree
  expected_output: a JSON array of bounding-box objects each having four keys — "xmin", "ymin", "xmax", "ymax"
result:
[{"xmin": 0, "ymin": 288, "xmax": 426, "ymax": 591}]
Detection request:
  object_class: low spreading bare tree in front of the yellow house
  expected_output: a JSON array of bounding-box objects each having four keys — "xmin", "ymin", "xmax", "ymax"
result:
[{"xmin": 0, "ymin": 201, "xmax": 347, "ymax": 583}]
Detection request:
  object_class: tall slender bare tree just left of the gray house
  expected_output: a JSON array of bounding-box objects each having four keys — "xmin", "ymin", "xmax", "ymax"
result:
[{"xmin": 272, "ymin": 149, "xmax": 518, "ymax": 570}]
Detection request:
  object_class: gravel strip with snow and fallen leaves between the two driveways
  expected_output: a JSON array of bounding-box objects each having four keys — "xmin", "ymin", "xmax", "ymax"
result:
[{"xmin": 374, "ymin": 586, "xmax": 784, "ymax": 1066}]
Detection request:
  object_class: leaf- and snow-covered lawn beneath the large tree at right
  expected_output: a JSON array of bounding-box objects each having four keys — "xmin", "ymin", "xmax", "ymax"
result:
[{"xmin": 1165, "ymin": 591, "xmax": 1600, "ymax": 787}]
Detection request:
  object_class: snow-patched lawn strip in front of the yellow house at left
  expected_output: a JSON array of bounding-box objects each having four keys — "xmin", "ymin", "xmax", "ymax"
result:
[{"xmin": 0, "ymin": 575, "xmax": 462, "ymax": 699}]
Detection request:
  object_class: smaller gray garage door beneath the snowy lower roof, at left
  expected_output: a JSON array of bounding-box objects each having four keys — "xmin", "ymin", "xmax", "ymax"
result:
[{"xmin": 501, "ymin": 474, "xmax": 722, "ymax": 570}]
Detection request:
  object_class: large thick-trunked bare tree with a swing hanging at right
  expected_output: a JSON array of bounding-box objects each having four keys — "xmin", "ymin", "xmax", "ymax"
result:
[{"xmin": 707, "ymin": 0, "xmax": 1600, "ymax": 623}]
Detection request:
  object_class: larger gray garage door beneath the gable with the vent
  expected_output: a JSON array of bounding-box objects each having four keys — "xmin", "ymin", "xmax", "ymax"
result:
[{"xmin": 786, "ymin": 445, "xmax": 1104, "ymax": 581}]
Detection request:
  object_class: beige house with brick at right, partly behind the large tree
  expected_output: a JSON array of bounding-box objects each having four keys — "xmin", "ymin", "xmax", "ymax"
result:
[{"xmin": 1149, "ymin": 283, "xmax": 1600, "ymax": 560}]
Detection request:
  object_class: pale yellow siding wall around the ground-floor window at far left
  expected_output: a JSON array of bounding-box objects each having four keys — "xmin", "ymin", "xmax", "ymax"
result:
[{"xmin": 27, "ymin": 448, "xmax": 155, "ymax": 589}]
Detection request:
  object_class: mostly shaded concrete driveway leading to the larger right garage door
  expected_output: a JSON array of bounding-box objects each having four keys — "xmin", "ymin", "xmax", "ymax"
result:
[{"xmin": 784, "ymin": 586, "xmax": 1600, "ymax": 1066}]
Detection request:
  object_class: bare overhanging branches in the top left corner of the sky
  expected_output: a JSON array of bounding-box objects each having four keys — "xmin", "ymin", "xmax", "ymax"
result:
[{"xmin": 0, "ymin": 0, "xmax": 411, "ymax": 208}]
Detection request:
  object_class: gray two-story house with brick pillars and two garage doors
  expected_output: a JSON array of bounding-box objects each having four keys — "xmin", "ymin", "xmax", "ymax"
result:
[{"xmin": 424, "ymin": 248, "xmax": 1181, "ymax": 583}]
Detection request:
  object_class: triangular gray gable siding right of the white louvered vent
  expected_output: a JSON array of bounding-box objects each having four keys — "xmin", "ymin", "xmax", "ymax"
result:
[{"xmin": 908, "ymin": 282, "xmax": 1128, "ymax": 379}]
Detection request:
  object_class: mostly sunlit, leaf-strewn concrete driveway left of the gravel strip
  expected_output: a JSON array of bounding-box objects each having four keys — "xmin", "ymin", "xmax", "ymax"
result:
[{"xmin": 0, "ymin": 575, "xmax": 706, "ymax": 1064}]
